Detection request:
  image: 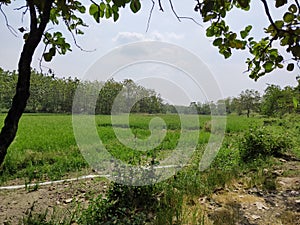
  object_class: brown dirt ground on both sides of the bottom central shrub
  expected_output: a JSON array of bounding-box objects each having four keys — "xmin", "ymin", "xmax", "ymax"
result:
[{"xmin": 0, "ymin": 159, "xmax": 300, "ymax": 225}]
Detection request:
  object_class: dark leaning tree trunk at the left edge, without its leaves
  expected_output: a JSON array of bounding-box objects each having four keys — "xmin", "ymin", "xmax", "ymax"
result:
[{"xmin": 0, "ymin": 0, "xmax": 54, "ymax": 165}]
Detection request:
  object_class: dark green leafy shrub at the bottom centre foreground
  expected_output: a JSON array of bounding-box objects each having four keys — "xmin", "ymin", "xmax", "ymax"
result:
[{"xmin": 79, "ymin": 183, "xmax": 156, "ymax": 225}]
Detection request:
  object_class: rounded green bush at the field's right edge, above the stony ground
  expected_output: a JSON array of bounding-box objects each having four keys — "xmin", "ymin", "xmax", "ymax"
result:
[{"xmin": 239, "ymin": 127, "xmax": 292, "ymax": 162}]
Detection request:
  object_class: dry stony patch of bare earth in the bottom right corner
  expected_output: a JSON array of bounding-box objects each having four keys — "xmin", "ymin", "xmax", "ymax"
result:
[{"xmin": 199, "ymin": 159, "xmax": 300, "ymax": 225}]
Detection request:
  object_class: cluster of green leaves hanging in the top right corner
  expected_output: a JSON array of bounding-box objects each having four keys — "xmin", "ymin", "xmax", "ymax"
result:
[{"xmin": 195, "ymin": 0, "xmax": 300, "ymax": 80}]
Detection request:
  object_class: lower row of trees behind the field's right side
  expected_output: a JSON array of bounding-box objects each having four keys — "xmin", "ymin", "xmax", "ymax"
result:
[{"xmin": 187, "ymin": 77, "xmax": 300, "ymax": 117}]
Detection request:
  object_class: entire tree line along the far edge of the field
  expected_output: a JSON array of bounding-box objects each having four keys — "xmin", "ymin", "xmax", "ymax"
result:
[{"xmin": 0, "ymin": 68, "xmax": 300, "ymax": 117}]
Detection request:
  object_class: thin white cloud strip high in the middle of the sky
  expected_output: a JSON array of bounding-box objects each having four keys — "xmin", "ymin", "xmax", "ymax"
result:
[{"xmin": 113, "ymin": 31, "xmax": 184, "ymax": 44}]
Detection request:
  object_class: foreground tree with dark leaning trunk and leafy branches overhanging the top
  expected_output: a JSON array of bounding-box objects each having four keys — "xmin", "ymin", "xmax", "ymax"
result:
[{"xmin": 0, "ymin": 0, "xmax": 300, "ymax": 165}]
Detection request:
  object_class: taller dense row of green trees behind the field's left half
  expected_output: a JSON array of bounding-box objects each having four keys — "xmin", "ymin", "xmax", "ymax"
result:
[{"xmin": 0, "ymin": 68, "xmax": 164, "ymax": 114}]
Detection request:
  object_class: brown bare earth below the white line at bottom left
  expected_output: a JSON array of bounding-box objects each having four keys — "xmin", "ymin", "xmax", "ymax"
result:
[{"xmin": 0, "ymin": 178, "xmax": 107, "ymax": 225}]
